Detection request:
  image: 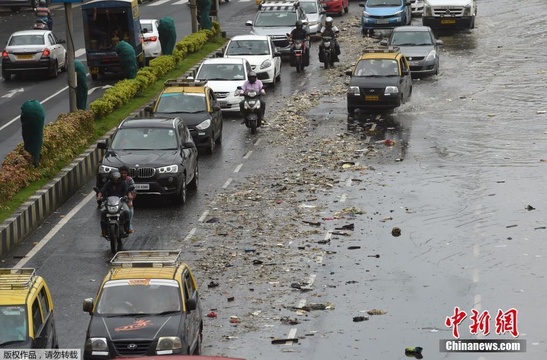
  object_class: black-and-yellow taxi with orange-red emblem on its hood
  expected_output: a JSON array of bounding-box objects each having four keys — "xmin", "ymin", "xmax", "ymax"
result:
[{"xmin": 83, "ymin": 250, "xmax": 203, "ymax": 360}]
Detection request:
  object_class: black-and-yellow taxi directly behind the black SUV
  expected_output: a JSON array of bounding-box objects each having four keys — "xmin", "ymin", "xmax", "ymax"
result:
[{"xmin": 145, "ymin": 79, "xmax": 224, "ymax": 154}]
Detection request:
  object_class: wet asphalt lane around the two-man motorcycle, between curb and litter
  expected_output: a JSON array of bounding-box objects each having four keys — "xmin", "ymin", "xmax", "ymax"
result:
[{"xmin": 3, "ymin": 112, "xmax": 274, "ymax": 348}]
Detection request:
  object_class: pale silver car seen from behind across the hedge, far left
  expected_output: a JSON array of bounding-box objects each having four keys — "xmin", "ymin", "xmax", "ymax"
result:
[{"xmin": 2, "ymin": 30, "xmax": 67, "ymax": 81}]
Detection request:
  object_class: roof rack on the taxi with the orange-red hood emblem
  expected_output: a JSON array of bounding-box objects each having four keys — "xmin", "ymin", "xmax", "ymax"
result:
[{"xmin": 110, "ymin": 250, "xmax": 182, "ymax": 268}]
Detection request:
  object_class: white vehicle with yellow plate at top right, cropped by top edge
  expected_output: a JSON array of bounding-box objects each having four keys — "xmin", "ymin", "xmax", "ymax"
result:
[{"xmin": 422, "ymin": 0, "xmax": 477, "ymax": 29}]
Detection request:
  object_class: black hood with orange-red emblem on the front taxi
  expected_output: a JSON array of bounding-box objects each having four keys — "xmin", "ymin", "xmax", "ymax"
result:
[{"xmin": 88, "ymin": 314, "xmax": 183, "ymax": 341}]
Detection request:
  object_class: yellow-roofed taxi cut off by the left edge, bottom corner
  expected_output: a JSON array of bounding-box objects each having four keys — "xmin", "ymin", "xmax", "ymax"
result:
[{"xmin": 0, "ymin": 268, "xmax": 59, "ymax": 349}]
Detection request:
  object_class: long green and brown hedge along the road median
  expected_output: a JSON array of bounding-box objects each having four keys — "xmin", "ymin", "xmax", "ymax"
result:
[{"xmin": 0, "ymin": 22, "xmax": 220, "ymax": 209}]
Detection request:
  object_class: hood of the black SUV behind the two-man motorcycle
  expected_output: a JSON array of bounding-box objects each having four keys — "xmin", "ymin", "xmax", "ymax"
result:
[{"xmin": 102, "ymin": 150, "xmax": 178, "ymax": 168}]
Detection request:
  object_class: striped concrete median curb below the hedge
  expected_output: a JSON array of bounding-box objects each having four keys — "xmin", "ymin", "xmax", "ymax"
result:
[{"xmin": 0, "ymin": 47, "xmax": 227, "ymax": 258}]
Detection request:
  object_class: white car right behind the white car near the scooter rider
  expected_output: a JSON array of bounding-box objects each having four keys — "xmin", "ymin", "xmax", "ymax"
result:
[{"xmin": 222, "ymin": 35, "xmax": 281, "ymax": 86}]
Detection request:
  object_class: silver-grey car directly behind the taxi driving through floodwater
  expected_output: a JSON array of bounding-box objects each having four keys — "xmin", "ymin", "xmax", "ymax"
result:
[{"xmin": 380, "ymin": 26, "xmax": 443, "ymax": 77}]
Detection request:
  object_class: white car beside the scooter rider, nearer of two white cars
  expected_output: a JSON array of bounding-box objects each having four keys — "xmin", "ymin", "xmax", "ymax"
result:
[{"xmin": 195, "ymin": 58, "xmax": 251, "ymax": 112}]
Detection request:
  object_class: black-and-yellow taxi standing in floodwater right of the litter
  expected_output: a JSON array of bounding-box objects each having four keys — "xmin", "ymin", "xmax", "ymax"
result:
[{"xmin": 346, "ymin": 47, "xmax": 412, "ymax": 114}]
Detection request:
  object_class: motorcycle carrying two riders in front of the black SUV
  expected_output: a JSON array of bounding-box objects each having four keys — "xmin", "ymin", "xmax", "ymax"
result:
[{"xmin": 93, "ymin": 187, "xmax": 129, "ymax": 254}]
